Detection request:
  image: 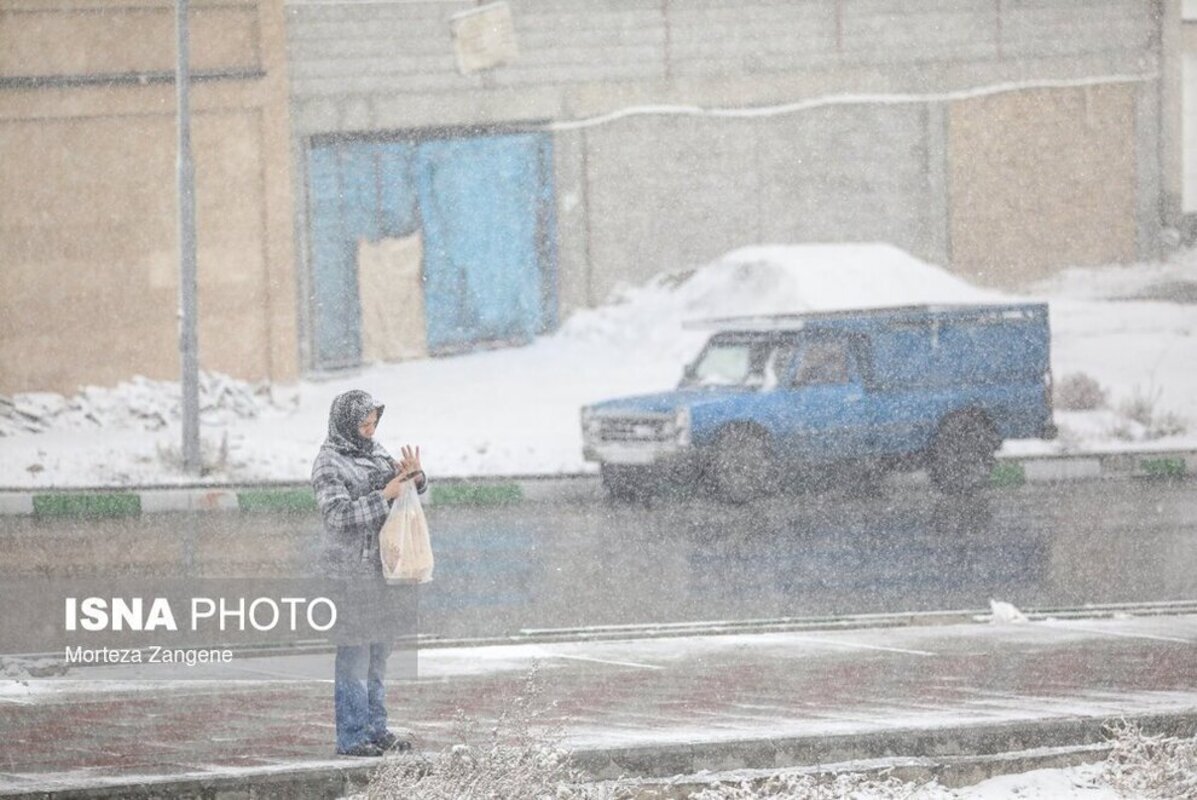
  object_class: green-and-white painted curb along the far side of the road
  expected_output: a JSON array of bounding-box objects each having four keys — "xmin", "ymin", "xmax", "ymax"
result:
[{"xmin": 0, "ymin": 450, "xmax": 1197, "ymax": 517}]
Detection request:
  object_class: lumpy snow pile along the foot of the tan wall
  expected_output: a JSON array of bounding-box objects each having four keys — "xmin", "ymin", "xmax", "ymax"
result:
[{"xmin": 0, "ymin": 372, "xmax": 296, "ymax": 436}]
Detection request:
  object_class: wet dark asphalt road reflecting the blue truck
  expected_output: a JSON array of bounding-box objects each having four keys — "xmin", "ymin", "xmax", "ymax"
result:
[{"xmin": 0, "ymin": 481, "xmax": 1197, "ymax": 636}]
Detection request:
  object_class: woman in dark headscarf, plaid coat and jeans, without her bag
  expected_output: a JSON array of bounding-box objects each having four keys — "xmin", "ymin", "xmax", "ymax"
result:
[{"xmin": 311, "ymin": 389, "xmax": 427, "ymax": 756}]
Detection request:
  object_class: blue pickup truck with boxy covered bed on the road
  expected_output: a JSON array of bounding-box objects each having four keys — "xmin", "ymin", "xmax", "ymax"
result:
[{"xmin": 582, "ymin": 304, "xmax": 1056, "ymax": 502}]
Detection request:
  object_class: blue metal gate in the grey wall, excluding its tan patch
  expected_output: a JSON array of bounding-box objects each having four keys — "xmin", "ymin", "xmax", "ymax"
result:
[{"xmin": 309, "ymin": 133, "xmax": 557, "ymax": 368}]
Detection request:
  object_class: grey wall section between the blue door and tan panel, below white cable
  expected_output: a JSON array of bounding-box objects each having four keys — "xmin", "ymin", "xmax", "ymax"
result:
[{"xmin": 574, "ymin": 105, "xmax": 937, "ymax": 303}]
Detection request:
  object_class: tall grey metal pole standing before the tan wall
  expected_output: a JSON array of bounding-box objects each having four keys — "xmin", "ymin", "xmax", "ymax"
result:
[{"xmin": 175, "ymin": 0, "xmax": 200, "ymax": 474}]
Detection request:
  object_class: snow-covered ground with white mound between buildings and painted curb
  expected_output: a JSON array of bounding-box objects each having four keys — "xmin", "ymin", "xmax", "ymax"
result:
[{"xmin": 0, "ymin": 244, "xmax": 1197, "ymax": 487}]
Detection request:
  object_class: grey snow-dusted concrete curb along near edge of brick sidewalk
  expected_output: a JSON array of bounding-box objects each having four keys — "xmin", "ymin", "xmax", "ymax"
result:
[{"xmin": 0, "ymin": 710, "xmax": 1197, "ymax": 800}]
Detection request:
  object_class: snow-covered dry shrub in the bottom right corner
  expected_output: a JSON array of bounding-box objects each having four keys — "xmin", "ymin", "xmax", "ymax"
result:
[{"xmin": 1104, "ymin": 722, "xmax": 1197, "ymax": 800}]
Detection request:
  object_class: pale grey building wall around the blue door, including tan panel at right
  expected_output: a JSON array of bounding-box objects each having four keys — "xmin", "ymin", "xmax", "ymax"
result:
[{"xmin": 287, "ymin": 0, "xmax": 1171, "ymax": 356}]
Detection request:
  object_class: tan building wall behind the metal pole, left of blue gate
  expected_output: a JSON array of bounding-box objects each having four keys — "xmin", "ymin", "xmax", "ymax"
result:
[{"xmin": 0, "ymin": 0, "xmax": 298, "ymax": 392}]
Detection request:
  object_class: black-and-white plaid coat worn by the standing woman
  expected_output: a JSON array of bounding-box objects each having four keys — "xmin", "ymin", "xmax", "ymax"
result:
[{"xmin": 311, "ymin": 444, "xmax": 427, "ymax": 575}]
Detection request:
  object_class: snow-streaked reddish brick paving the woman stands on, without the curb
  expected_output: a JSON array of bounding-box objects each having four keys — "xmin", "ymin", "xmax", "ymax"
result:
[{"xmin": 0, "ymin": 616, "xmax": 1197, "ymax": 793}]
